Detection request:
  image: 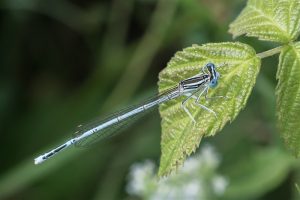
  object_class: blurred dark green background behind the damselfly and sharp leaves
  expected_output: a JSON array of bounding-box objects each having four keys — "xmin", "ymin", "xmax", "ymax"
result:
[{"xmin": 0, "ymin": 0, "xmax": 300, "ymax": 200}]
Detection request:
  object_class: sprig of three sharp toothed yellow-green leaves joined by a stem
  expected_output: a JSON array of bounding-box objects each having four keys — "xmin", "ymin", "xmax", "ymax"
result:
[{"xmin": 159, "ymin": 0, "xmax": 300, "ymax": 176}]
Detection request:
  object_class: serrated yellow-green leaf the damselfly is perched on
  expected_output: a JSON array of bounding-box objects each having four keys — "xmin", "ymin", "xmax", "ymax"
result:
[{"xmin": 159, "ymin": 42, "xmax": 260, "ymax": 176}]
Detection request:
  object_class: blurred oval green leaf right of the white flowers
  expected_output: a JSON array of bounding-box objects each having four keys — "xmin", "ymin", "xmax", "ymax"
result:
[{"xmin": 224, "ymin": 147, "xmax": 294, "ymax": 200}]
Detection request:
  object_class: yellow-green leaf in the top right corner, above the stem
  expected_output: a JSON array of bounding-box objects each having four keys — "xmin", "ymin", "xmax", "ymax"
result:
[{"xmin": 229, "ymin": 0, "xmax": 300, "ymax": 43}]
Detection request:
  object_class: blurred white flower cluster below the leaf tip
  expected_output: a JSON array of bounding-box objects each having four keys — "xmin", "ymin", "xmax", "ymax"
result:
[{"xmin": 126, "ymin": 145, "xmax": 228, "ymax": 200}]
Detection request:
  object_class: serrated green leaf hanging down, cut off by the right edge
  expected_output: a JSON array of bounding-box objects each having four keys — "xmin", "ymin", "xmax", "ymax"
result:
[{"xmin": 276, "ymin": 42, "xmax": 300, "ymax": 157}]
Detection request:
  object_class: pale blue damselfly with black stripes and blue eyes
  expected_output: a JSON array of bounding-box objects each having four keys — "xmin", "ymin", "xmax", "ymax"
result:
[{"xmin": 34, "ymin": 63, "xmax": 220, "ymax": 164}]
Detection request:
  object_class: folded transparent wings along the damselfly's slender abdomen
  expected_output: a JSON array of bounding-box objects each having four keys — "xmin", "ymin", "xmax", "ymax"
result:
[{"xmin": 73, "ymin": 87, "xmax": 177, "ymax": 147}]
